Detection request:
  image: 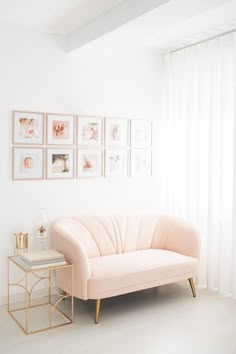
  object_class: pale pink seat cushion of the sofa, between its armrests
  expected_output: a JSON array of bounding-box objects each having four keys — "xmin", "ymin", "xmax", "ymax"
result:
[{"xmin": 88, "ymin": 249, "xmax": 198, "ymax": 299}]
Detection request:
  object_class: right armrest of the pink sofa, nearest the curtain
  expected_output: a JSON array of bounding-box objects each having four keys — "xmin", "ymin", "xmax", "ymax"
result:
[{"xmin": 153, "ymin": 216, "xmax": 200, "ymax": 259}]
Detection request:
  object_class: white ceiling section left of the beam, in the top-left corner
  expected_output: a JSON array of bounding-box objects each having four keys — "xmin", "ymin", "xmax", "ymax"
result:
[{"xmin": 0, "ymin": 0, "xmax": 125, "ymax": 35}]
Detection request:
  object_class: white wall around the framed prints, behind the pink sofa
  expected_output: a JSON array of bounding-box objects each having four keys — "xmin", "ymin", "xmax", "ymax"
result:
[{"xmin": 0, "ymin": 27, "xmax": 161, "ymax": 302}]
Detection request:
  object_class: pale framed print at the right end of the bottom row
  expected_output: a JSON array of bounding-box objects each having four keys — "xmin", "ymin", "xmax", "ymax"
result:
[{"xmin": 131, "ymin": 149, "xmax": 152, "ymax": 177}]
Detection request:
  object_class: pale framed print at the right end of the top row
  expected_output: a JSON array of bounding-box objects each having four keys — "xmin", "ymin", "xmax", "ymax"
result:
[{"xmin": 131, "ymin": 119, "xmax": 152, "ymax": 148}]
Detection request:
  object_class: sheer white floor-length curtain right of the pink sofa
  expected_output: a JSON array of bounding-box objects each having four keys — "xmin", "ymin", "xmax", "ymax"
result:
[{"xmin": 157, "ymin": 33, "xmax": 236, "ymax": 297}]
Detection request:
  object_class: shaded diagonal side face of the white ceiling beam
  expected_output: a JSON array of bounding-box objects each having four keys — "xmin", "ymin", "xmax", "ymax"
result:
[{"xmin": 67, "ymin": 0, "xmax": 170, "ymax": 52}]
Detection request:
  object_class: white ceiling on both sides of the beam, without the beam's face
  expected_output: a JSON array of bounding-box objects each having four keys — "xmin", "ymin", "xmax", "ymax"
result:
[{"xmin": 0, "ymin": 0, "xmax": 236, "ymax": 51}]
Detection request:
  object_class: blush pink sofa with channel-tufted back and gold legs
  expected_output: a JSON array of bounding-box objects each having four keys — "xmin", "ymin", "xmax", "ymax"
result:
[{"xmin": 52, "ymin": 215, "xmax": 200, "ymax": 323}]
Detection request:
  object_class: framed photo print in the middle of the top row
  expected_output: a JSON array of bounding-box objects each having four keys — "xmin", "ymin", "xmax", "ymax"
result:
[{"xmin": 77, "ymin": 117, "xmax": 103, "ymax": 146}]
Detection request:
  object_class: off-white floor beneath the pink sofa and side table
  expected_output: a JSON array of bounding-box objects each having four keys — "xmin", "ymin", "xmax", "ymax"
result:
[{"xmin": 0, "ymin": 282, "xmax": 236, "ymax": 354}]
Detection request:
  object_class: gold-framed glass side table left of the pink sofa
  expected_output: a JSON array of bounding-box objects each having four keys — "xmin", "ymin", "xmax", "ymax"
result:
[{"xmin": 8, "ymin": 256, "xmax": 74, "ymax": 334}]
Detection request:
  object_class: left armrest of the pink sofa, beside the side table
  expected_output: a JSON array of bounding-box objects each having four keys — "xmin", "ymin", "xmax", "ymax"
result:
[{"xmin": 52, "ymin": 222, "xmax": 91, "ymax": 300}]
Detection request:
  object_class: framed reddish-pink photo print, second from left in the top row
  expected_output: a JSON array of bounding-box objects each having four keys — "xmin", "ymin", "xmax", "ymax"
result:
[{"xmin": 47, "ymin": 114, "xmax": 75, "ymax": 145}]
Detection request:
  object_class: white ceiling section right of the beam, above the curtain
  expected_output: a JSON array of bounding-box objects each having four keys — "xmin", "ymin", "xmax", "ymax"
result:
[{"xmin": 92, "ymin": 0, "xmax": 236, "ymax": 52}]
